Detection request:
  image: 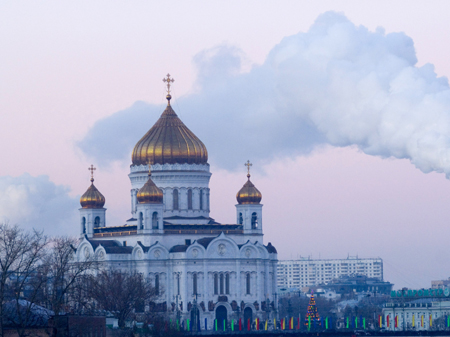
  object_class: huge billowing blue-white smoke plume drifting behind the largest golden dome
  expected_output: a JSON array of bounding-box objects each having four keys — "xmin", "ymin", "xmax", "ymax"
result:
[{"xmin": 80, "ymin": 12, "xmax": 450, "ymax": 176}]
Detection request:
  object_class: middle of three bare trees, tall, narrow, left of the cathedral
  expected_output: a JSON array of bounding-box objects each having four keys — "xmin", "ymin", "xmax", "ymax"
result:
[{"xmin": 45, "ymin": 237, "xmax": 97, "ymax": 315}]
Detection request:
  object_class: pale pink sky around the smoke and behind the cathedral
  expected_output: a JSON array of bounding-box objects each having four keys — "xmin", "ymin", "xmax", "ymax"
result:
[{"xmin": 0, "ymin": 1, "xmax": 450, "ymax": 288}]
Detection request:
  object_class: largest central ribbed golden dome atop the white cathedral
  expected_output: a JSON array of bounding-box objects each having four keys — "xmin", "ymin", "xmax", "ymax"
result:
[{"xmin": 131, "ymin": 94, "xmax": 208, "ymax": 165}]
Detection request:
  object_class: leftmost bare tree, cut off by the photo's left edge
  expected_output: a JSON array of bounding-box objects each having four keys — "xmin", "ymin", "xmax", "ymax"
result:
[{"xmin": 0, "ymin": 223, "xmax": 48, "ymax": 336}]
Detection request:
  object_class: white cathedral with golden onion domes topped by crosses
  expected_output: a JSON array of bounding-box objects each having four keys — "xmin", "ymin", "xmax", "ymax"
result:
[{"xmin": 76, "ymin": 75, "xmax": 277, "ymax": 329}]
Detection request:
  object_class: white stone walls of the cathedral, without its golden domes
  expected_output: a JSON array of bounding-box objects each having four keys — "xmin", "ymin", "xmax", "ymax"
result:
[{"xmin": 77, "ymin": 164, "xmax": 277, "ymax": 328}]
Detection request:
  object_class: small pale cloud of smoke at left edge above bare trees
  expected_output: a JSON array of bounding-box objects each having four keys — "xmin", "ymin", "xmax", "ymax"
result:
[{"xmin": 0, "ymin": 173, "xmax": 80, "ymax": 236}]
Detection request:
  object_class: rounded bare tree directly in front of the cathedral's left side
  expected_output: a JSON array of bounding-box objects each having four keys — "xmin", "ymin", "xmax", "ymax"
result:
[{"xmin": 89, "ymin": 270, "xmax": 156, "ymax": 328}]
